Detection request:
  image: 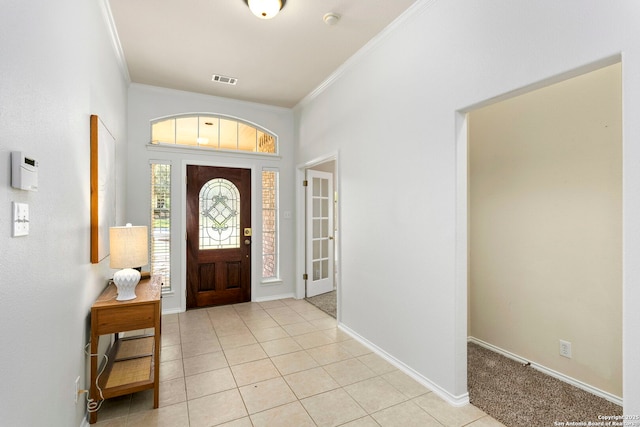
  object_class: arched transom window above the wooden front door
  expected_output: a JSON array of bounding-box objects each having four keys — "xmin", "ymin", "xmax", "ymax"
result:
[{"xmin": 151, "ymin": 114, "xmax": 278, "ymax": 154}]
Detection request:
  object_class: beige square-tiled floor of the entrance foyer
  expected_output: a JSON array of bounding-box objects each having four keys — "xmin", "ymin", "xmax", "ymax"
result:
[{"xmin": 94, "ymin": 299, "xmax": 502, "ymax": 427}]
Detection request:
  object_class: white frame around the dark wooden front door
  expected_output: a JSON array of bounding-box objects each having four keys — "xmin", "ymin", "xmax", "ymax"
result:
[{"xmin": 176, "ymin": 159, "xmax": 262, "ymax": 312}]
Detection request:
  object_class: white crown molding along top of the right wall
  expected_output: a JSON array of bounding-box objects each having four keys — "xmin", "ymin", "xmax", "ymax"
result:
[{"xmin": 293, "ymin": 0, "xmax": 436, "ymax": 110}]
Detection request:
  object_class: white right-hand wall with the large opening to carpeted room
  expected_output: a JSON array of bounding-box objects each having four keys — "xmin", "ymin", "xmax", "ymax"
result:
[{"xmin": 296, "ymin": 0, "xmax": 640, "ymax": 414}]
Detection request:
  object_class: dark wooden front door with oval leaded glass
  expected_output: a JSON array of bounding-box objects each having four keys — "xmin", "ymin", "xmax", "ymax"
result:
[{"xmin": 186, "ymin": 165, "xmax": 251, "ymax": 308}]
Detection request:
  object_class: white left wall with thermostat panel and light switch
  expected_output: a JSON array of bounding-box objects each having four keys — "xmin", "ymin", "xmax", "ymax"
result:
[{"xmin": 0, "ymin": 0, "xmax": 126, "ymax": 426}]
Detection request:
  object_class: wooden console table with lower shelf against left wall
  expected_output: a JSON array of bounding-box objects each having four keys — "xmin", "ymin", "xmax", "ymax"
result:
[{"xmin": 89, "ymin": 276, "xmax": 162, "ymax": 424}]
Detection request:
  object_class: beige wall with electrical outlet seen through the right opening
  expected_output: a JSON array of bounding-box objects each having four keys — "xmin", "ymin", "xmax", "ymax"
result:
[{"xmin": 469, "ymin": 64, "xmax": 622, "ymax": 397}]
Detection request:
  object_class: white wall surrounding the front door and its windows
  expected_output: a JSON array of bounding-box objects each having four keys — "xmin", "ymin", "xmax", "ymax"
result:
[{"xmin": 126, "ymin": 84, "xmax": 294, "ymax": 313}]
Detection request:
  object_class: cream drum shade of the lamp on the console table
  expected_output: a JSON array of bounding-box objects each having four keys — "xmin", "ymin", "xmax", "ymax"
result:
[{"xmin": 109, "ymin": 224, "xmax": 149, "ymax": 268}]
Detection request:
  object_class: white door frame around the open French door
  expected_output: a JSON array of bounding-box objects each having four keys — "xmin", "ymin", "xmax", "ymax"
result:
[{"xmin": 295, "ymin": 151, "xmax": 342, "ymax": 323}]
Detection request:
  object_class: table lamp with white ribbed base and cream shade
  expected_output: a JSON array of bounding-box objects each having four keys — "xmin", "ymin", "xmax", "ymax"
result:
[{"xmin": 109, "ymin": 224, "xmax": 149, "ymax": 301}]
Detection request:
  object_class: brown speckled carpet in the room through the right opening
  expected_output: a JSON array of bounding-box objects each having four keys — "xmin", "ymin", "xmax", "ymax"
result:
[{"xmin": 467, "ymin": 343, "xmax": 622, "ymax": 427}]
